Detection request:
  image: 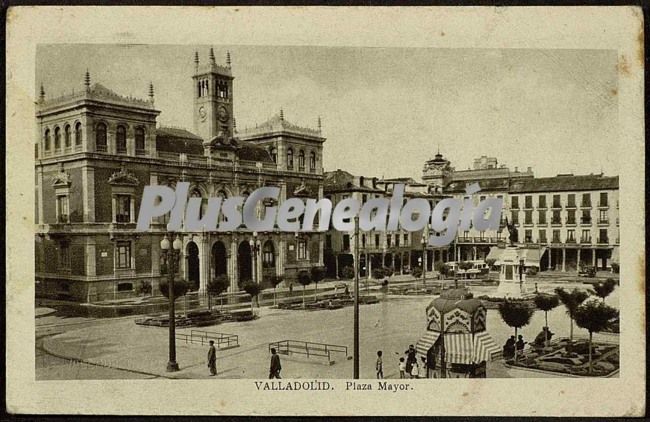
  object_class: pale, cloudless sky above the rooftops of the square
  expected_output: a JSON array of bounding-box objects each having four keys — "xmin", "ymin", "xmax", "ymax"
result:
[{"xmin": 36, "ymin": 44, "xmax": 619, "ymax": 179}]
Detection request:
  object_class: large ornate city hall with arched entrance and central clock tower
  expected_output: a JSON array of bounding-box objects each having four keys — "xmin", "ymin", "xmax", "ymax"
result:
[{"xmin": 35, "ymin": 49, "xmax": 325, "ymax": 302}]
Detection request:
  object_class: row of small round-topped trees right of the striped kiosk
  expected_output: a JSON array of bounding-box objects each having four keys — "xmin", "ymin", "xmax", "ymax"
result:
[{"xmin": 499, "ymin": 279, "xmax": 618, "ymax": 373}]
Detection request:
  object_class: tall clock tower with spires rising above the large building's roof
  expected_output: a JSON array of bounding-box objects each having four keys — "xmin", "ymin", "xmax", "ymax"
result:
[{"xmin": 192, "ymin": 48, "xmax": 234, "ymax": 142}]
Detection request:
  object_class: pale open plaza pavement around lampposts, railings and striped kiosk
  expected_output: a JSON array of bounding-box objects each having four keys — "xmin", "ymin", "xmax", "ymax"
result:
[{"xmin": 42, "ymin": 283, "xmax": 618, "ymax": 379}]
